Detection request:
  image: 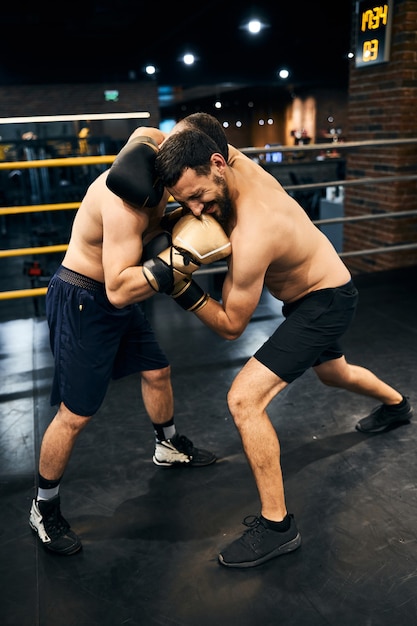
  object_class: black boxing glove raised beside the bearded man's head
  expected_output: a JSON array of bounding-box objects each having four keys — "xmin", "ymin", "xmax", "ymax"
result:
[{"xmin": 106, "ymin": 136, "xmax": 164, "ymax": 207}]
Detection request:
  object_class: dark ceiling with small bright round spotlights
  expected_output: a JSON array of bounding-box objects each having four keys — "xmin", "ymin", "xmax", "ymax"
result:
[{"xmin": 0, "ymin": 0, "xmax": 354, "ymax": 88}]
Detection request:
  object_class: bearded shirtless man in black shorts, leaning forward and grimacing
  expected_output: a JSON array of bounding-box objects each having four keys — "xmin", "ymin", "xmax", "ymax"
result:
[{"xmin": 156, "ymin": 116, "xmax": 412, "ymax": 567}]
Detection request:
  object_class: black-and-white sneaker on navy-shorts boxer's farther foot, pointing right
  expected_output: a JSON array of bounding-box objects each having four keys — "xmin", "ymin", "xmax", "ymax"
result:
[{"xmin": 152, "ymin": 433, "xmax": 217, "ymax": 467}]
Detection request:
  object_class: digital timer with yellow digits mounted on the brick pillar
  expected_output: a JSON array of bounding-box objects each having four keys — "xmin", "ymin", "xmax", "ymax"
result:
[{"xmin": 355, "ymin": 0, "xmax": 393, "ymax": 67}]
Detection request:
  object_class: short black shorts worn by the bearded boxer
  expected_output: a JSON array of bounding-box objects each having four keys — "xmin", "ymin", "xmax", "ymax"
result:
[{"xmin": 254, "ymin": 281, "xmax": 358, "ymax": 383}]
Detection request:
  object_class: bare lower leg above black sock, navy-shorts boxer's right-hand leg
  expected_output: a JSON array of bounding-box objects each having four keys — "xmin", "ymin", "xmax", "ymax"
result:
[{"xmin": 142, "ymin": 367, "xmax": 174, "ymax": 424}]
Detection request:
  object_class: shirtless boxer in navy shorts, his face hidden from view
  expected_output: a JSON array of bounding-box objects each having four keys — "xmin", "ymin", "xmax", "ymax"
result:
[{"xmin": 29, "ymin": 123, "xmax": 230, "ymax": 555}]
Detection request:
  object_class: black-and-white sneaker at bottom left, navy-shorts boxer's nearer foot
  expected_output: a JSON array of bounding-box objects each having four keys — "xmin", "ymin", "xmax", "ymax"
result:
[{"xmin": 29, "ymin": 496, "xmax": 82, "ymax": 555}]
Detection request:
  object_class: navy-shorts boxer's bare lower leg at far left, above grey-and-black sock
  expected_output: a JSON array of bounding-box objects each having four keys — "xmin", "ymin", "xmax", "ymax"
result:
[{"xmin": 39, "ymin": 403, "xmax": 91, "ymax": 480}]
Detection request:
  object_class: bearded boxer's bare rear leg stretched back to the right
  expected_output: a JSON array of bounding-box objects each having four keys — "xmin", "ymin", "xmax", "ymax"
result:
[{"xmin": 314, "ymin": 356, "xmax": 403, "ymax": 404}]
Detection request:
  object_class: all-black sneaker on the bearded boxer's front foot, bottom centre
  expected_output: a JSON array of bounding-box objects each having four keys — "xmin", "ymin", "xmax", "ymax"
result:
[{"xmin": 219, "ymin": 515, "xmax": 301, "ymax": 567}]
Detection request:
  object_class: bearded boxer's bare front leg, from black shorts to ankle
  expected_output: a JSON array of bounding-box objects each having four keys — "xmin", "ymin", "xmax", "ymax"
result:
[{"xmin": 228, "ymin": 357, "xmax": 287, "ymax": 522}]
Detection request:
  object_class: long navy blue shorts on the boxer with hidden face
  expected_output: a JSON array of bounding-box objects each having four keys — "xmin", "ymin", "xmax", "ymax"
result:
[{"xmin": 46, "ymin": 265, "xmax": 169, "ymax": 417}]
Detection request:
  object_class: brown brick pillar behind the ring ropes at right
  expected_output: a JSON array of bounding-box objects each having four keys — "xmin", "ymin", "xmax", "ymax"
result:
[{"xmin": 344, "ymin": 0, "xmax": 417, "ymax": 273}]
